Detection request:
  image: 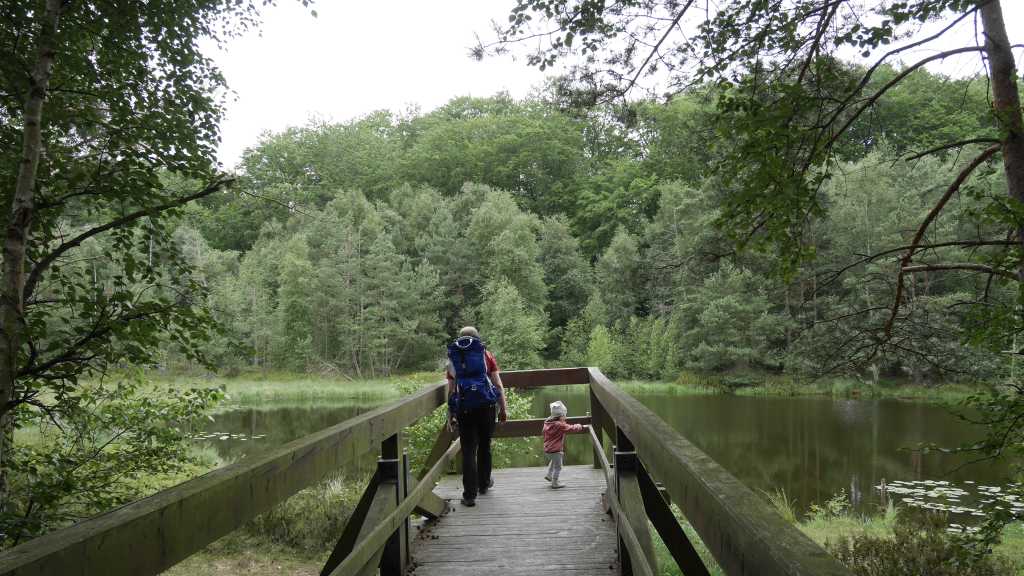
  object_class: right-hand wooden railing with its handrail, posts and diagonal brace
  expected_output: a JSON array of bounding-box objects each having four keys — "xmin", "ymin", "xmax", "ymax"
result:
[{"xmin": 587, "ymin": 368, "xmax": 851, "ymax": 576}]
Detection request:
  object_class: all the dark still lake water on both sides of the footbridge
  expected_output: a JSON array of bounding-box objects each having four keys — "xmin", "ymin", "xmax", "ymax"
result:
[{"xmin": 201, "ymin": 385, "xmax": 1010, "ymax": 508}]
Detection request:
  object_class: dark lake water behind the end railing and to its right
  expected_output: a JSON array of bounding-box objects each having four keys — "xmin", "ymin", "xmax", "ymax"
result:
[{"xmin": 524, "ymin": 387, "xmax": 1006, "ymax": 506}]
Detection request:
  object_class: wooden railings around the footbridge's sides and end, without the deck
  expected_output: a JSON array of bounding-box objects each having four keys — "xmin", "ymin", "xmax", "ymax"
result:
[{"xmin": 0, "ymin": 368, "xmax": 850, "ymax": 576}]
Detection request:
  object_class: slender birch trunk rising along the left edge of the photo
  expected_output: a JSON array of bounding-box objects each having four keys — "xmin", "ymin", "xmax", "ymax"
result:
[{"xmin": 0, "ymin": 0, "xmax": 61, "ymax": 511}]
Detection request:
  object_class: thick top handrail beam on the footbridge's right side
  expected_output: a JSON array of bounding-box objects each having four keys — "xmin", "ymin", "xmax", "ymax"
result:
[{"xmin": 590, "ymin": 368, "xmax": 850, "ymax": 576}]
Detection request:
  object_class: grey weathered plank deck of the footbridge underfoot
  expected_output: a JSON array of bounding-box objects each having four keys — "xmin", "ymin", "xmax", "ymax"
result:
[{"xmin": 412, "ymin": 465, "xmax": 618, "ymax": 576}]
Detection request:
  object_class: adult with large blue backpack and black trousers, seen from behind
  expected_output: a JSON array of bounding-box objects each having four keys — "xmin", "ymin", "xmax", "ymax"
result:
[{"xmin": 444, "ymin": 326, "xmax": 508, "ymax": 506}]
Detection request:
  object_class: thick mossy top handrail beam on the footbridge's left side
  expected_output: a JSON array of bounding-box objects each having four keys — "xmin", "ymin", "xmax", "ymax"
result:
[{"xmin": 0, "ymin": 383, "xmax": 444, "ymax": 576}]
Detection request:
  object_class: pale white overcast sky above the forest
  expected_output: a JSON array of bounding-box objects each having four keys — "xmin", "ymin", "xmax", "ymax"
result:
[{"xmin": 211, "ymin": 0, "xmax": 1024, "ymax": 168}]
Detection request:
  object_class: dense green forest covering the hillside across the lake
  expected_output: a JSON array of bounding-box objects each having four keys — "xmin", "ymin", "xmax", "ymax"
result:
[{"xmin": 140, "ymin": 69, "xmax": 1011, "ymax": 382}]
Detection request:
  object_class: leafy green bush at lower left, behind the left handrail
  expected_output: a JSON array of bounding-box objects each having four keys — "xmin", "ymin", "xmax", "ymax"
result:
[{"xmin": 0, "ymin": 374, "xmax": 224, "ymax": 546}]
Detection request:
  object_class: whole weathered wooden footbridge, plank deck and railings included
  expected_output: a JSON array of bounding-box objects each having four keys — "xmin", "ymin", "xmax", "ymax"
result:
[{"xmin": 0, "ymin": 368, "xmax": 850, "ymax": 576}]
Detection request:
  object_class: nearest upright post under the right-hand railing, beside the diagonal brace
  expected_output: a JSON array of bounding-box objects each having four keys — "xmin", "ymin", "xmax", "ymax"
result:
[{"xmin": 614, "ymin": 426, "xmax": 657, "ymax": 576}]
